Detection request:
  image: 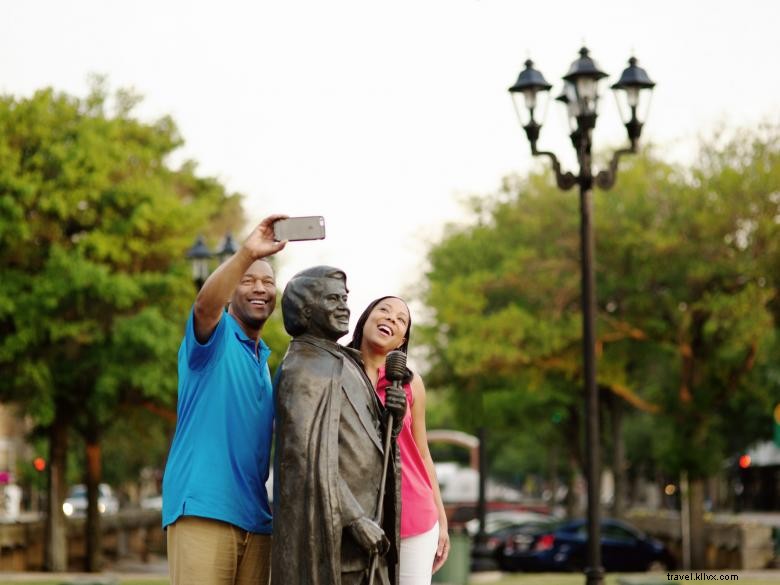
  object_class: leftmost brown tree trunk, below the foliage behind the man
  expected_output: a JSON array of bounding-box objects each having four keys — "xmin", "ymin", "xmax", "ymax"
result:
[{"xmin": 46, "ymin": 415, "xmax": 68, "ymax": 572}]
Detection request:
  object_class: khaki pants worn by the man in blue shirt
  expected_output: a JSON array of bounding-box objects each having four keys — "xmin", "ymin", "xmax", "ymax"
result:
[{"xmin": 167, "ymin": 516, "xmax": 271, "ymax": 585}]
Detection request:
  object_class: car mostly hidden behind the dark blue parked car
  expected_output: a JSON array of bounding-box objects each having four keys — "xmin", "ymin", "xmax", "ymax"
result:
[{"xmin": 466, "ymin": 510, "xmax": 559, "ymax": 571}]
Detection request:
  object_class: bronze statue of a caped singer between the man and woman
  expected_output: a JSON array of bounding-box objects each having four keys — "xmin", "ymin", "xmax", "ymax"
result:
[{"xmin": 271, "ymin": 266, "xmax": 406, "ymax": 585}]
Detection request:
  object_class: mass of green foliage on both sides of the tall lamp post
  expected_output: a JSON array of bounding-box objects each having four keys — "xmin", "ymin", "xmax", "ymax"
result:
[{"xmin": 422, "ymin": 127, "xmax": 780, "ymax": 477}]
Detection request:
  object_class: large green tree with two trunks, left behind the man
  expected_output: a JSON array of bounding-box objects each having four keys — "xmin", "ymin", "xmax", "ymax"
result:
[{"xmin": 0, "ymin": 79, "xmax": 243, "ymax": 570}]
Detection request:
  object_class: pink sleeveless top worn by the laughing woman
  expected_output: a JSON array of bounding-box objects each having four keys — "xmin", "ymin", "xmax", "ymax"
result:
[{"xmin": 376, "ymin": 366, "xmax": 439, "ymax": 538}]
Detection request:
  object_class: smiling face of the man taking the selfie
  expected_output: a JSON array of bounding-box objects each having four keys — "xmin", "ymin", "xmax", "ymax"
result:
[{"xmin": 230, "ymin": 260, "xmax": 276, "ymax": 330}]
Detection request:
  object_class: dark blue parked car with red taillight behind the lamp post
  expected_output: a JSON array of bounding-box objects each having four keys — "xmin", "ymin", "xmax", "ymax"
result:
[{"xmin": 497, "ymin": 519, "xmax": 674, "ymax": 571}]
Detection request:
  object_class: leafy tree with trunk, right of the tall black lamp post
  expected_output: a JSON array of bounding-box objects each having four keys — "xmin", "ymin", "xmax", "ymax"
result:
[{"xmin": 601, "ymin": 126, "xmax": 780, "ymax": 567}]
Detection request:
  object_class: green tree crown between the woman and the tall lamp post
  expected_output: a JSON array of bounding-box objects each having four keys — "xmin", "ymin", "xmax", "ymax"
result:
[{"xmin": 424, "ymin": 176, "xmax": 596, "ymax": 512}]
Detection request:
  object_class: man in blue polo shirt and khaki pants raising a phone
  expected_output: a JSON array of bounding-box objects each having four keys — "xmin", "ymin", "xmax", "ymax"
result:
[{"xmin": 163, "ymin": 215, "xmax": 286, "ymax": 585}]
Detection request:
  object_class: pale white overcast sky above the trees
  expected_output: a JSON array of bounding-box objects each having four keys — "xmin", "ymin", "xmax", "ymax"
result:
[{"xmin": 0, "ymin": 0, "xmax": 780, "ymax": 340}]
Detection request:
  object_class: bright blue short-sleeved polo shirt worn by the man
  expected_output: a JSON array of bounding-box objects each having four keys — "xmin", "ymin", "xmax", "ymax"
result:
[{"xmin": 162, "ymin": 312, "xmax": 274, "ymax": 534}]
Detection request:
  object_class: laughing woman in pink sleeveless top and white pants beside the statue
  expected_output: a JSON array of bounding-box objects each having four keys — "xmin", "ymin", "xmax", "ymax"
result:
[{"xmin": 349, "ymin": 296, "xmax": 450, "ymax": 585}]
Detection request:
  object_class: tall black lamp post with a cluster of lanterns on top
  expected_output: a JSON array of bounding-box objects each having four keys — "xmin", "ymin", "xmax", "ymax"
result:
[{"xmin": 509, "ymin": 47, "xmax": 655, "ymax": 585}]
